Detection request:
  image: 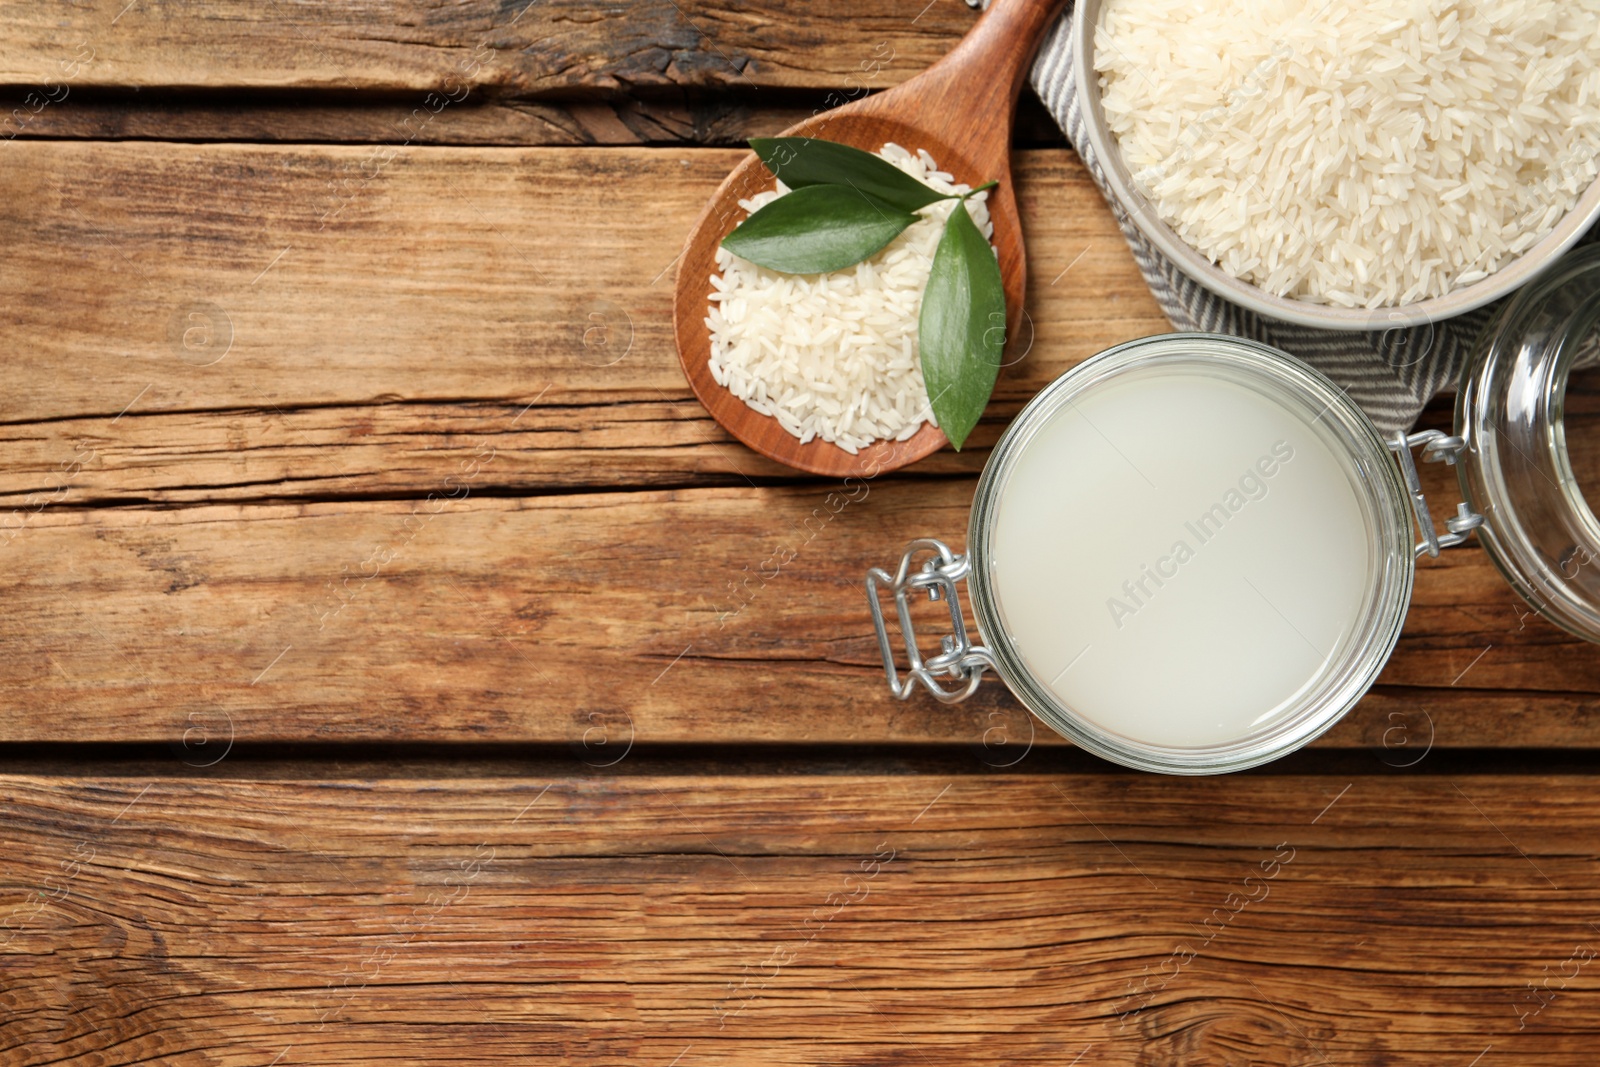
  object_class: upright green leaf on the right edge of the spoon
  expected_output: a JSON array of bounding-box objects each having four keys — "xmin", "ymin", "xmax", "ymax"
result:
[{"xmin": 917, "ymin": 203, "xmax": 1005, "ymax": 451}]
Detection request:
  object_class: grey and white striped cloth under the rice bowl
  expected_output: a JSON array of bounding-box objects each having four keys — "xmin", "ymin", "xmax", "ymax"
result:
[{"xmin": 1032, "ymin": 10, "xmax": 1600, "ymax": 434}]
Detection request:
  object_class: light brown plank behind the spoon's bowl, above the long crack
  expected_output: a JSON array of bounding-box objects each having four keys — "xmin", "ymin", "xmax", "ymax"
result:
[{"xmin": 0, "ymin": 141, "xmax": 1166, "ymax": 425}]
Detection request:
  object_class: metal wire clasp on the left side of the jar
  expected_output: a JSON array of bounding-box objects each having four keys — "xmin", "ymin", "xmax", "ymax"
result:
[{"xmin": 867, "ymin": 537, "xmax": 994, "ymax": 704}]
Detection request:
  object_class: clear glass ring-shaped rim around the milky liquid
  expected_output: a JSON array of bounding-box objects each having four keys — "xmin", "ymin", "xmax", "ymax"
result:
[{"xmin": 966, "ymin": 333, "xmax": 1414, "ymax": 774}]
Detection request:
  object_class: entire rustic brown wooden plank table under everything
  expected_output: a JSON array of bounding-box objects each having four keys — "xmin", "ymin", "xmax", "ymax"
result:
[{"xmin": 0, "ymin": 0, "xmax": 1600, "ymax": 1067}]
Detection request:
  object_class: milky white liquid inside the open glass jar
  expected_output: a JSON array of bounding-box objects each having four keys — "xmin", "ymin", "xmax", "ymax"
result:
[{"xmin": 987, "ymin": 368, "xmax": 1376, "ymax": 747}]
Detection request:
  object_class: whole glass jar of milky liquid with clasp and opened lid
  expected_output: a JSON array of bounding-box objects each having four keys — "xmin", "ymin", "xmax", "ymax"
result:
[{"xmin": 867, "ymin": 248, "xmax": 1600, "ymax": 774}]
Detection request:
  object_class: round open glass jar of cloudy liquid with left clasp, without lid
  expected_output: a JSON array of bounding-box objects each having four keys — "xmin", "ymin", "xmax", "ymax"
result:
[{"xmin": 867, "ymin": 334, "xmax": 1416, "ymax": 774}]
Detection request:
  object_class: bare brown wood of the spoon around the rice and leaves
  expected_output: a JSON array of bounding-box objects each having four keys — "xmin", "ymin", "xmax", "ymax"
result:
[{"xmin": 672, "ymin": 0, "xmax": 1066, "ymax": 478}]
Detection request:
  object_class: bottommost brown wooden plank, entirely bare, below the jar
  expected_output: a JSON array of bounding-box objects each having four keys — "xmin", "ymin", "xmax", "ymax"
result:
[{"xmin": 0, "ymin": 765, "xmax": 1600, "ymax": 1067}]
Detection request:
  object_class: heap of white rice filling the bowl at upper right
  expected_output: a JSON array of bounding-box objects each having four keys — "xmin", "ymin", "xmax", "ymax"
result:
[{"xmin": 1094, "ymin": 0, "xmax": 1600, "ymax": 307}]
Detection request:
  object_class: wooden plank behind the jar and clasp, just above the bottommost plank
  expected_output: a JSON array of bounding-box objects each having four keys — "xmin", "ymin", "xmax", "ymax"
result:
[{"xmin": 0, "ymin": 479, "xmax": 1600, "ymax": 748}]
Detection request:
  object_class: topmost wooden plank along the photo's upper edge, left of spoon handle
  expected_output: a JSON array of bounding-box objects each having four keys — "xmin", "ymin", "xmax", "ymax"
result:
[{"xmin": 0, "ymin": 0, "xmax": 976, "ymax": 93}]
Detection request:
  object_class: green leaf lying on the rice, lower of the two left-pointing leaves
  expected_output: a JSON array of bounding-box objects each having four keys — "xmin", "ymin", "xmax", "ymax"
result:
[{"xmin": 722, "ymin": 186, "xmax": 917, "ymax": 274}]
